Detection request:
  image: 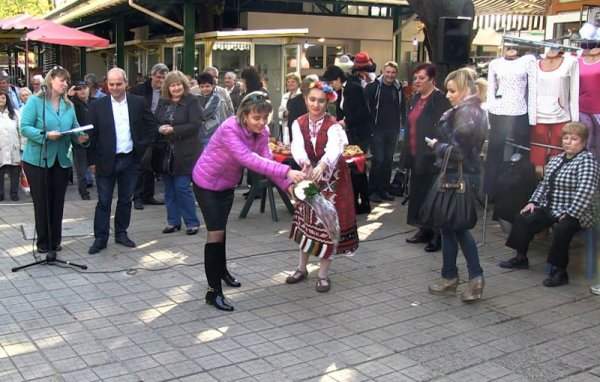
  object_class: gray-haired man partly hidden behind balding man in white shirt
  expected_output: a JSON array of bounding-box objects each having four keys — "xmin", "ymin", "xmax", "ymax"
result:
[{"xmin": 131, "ymin": 63, "xmax": 169, "ymax": 210}]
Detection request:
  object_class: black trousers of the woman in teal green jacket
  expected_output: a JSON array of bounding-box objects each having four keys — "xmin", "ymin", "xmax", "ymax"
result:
[{"xmin": 23, "ymin": 159, "xmax": 69, "ymax": 249}]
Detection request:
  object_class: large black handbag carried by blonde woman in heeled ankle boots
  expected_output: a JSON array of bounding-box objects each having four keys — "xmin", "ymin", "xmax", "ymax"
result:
[{"xmin": 419, "ymin": 146, "xmax": 477, "ymax": 231}]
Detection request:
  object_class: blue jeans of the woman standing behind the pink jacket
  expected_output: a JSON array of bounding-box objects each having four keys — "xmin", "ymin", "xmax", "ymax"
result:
[{"xmin": 162, "ymin": 174, "xmax": 200, "ymax": 228}]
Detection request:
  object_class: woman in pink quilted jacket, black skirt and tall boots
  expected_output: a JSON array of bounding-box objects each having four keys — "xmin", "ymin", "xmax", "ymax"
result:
[{"xmin": 192, "ymin": 91, "xmax": 304, "ymax": 311}]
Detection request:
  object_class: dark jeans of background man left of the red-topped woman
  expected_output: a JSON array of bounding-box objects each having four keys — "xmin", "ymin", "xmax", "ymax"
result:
[{"xmin": 369, "ymin": 129, "xmax": 398, "ymax": 195}]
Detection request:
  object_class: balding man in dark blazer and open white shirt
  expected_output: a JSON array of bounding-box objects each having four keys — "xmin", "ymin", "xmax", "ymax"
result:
[{"xmin": 89, "ymin": 68, "xmax": 159, "ymax": 255}]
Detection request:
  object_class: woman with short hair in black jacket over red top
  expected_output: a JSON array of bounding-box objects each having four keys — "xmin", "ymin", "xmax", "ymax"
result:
[{"xmin": 402, "ymin": 63, "xmax": 451, "ymax": 252}]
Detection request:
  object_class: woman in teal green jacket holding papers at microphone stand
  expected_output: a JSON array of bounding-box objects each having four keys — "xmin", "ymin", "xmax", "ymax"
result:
[{"xmin": 21, "ymin": 66, "xmax": 88, "ymax": 253}]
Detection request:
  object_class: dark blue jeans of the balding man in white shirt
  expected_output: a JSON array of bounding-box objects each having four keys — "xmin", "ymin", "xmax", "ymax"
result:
[{"xmin": 94, "ymin": 153, "xmax": 138, "ymax": 243}]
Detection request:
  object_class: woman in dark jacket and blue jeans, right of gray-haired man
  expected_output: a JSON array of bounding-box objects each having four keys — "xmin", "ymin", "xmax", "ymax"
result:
[{"xmin": 154, "ymin": 71, "xmax": 202, "ymax": 235}]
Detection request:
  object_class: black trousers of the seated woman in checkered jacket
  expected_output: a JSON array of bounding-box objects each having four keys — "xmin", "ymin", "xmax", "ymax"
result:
[{"xmin": 506, "ymin": 209, "xmax": 581, "ymax": 269}]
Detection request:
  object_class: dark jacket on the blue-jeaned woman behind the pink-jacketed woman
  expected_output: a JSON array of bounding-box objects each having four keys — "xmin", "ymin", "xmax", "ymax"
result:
[{"xmin": 154, "ymin": 94, "xmax": 202, "ymax": 175}]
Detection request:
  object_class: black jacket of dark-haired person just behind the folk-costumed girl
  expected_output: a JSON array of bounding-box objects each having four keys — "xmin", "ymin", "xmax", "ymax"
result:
[{"xmin": 335, "ymin": 81, "xmax": 373, "ymax": 144}]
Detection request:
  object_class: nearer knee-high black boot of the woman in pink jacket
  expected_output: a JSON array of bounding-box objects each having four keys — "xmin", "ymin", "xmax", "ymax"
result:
[{"xmin": 204, "ymin": 243, "xmax": 233, "ymax": 311}]
